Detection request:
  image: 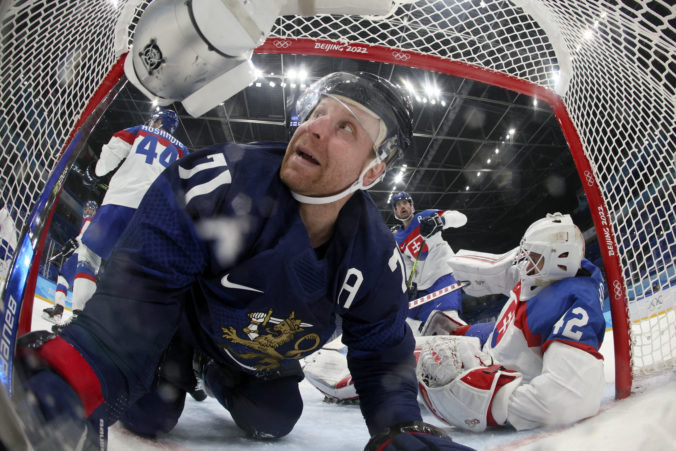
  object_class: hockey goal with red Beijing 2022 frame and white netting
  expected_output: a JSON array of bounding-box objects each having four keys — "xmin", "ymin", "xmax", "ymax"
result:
[{"xmin": 0, "ymin": 0, "xmax": 676, "ymax": 397}]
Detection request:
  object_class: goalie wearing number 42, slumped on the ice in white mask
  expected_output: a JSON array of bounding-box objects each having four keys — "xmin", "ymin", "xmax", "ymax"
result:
[{"xmin": 417, "ymin": 213, "xmax": 605, "ymax": 431}]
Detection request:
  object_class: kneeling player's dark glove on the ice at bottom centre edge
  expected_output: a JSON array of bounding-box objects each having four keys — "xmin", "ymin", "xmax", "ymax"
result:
[{"xmin": 364, "ymin": 421, "xmax": 472, "ymax": 451}]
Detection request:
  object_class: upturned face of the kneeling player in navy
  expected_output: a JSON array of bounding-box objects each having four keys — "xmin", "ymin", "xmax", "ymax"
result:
[{"xmin": 280, "ymin": 97, "xmax": 380, "ymax": 196}]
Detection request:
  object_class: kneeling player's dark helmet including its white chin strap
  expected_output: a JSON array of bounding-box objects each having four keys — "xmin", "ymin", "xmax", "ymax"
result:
[{"xmin": 292, "ymin": 72, "xmax": 413, "ymax": 204}]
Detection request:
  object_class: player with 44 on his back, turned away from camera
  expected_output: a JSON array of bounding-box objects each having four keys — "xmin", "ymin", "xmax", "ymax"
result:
[{"xmin": 64, "ymin": 110, "xmax": 188, "ymax": 332}]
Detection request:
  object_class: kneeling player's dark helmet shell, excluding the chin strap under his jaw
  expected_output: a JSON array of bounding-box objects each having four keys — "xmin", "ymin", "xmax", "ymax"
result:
[{"xmin": 296, "ymin": 72, "xmax": 413, "ymax": 188}]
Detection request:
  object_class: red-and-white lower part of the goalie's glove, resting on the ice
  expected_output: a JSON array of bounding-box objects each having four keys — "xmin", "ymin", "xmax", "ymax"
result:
[{"xmin": 419, "ymin": 365, "xmax": 522, "ymax": 432}]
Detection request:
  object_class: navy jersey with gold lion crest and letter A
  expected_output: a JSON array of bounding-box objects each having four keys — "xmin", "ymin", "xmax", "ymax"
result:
[{"xmin": 64, "ymin": 143, "xmax": 420, "ymax": 433}]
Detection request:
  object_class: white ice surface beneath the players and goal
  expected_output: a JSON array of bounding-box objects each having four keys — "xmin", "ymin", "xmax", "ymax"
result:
[{"xmin": 33, "ymin": 298, "xmax": 676, "ymax": 451}]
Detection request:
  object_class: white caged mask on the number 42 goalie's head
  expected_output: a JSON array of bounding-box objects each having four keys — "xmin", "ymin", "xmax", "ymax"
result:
[{"xmin": 514, "ymin": 213, "xmax": 585, "ymax": 301}]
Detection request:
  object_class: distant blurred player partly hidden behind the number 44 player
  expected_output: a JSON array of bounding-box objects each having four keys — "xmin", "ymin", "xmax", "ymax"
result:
[{"xmin": 42, "ymin": 200, "xmax": 99, "ymax": 324}]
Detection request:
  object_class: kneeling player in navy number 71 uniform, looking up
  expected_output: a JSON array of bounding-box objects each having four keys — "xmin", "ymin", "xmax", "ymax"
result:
[{"xmin": 22, "ymin": 73, "xmax": 476, "ymax": 450}]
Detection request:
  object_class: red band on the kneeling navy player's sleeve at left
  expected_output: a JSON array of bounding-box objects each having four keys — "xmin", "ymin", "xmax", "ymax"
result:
[{"xmin": 39, "ymin": 337, "xmax": 105, "ymax": 417}]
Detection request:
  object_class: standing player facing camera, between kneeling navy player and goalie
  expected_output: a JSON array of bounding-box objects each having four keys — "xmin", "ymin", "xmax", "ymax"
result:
[{"xmin": 392, "ymin": 192, "xmax": 467, "ymax": 334}]
